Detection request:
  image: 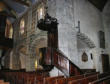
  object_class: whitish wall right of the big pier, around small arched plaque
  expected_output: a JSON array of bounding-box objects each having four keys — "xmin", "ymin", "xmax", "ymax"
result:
[{"xmin": 74, "ymin": 0, "xmax": 104, "ymax": 72}]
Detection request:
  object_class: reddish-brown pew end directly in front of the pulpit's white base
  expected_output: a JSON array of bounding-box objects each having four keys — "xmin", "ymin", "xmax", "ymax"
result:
[{"xmin": 43, "ymin": 76, "xmax": 64, "ymax": 84}]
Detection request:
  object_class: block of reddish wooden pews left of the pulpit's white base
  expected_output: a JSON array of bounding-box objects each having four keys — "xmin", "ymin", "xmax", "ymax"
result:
[{"xmin": 0, "ymin": 71, "xmax": 49, "ymax": 84}]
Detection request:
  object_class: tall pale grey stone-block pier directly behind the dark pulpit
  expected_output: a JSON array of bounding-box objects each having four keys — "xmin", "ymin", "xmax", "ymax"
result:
[{"xmin": 47, "ymin": 0, "xmax": 78, "ymax": 65}]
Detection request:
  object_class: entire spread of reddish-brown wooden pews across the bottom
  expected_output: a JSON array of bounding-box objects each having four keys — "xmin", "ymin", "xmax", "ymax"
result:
[{"xmin": 0, "ymin": 72, "xmax": 110, "ymax": 84}]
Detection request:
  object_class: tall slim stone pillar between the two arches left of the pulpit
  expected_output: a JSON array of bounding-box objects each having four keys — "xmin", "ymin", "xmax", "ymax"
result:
[{"xmin": 26, "ymin": 7, "xmax": 34, "ymax": 71}]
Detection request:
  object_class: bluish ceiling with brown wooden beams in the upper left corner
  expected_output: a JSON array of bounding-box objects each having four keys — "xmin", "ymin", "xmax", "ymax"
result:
[{"xmin": 0, "ymin": 0, "xmax": 37, "ymax": 17}]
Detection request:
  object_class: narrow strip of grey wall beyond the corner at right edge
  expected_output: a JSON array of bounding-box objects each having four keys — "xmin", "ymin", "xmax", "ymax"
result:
[{"xmin": 103, "ymin": 0, "xmax": 110, "ymax": 67}]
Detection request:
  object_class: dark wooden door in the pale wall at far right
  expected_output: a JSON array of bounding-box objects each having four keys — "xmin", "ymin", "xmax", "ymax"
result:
[{"xmin": 101, "ymin": 54, "xmax": 109, "ymax": 72}]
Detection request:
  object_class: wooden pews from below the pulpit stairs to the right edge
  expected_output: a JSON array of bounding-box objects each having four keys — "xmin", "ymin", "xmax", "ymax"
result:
[{"xmin": 43, "ymin": 72, "xmax": 110, "ymax": 84}]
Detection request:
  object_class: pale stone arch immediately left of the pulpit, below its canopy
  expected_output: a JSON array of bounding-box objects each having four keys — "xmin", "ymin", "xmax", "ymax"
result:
[{"xmin": 29, "ymin": 36, "xmax": 47, "ymax": 70}]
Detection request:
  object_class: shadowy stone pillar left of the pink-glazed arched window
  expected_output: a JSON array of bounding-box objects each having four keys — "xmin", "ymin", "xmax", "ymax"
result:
[{"xmin": 11, "ymin": 19, "xmax": 20, "ymax": 70}]
